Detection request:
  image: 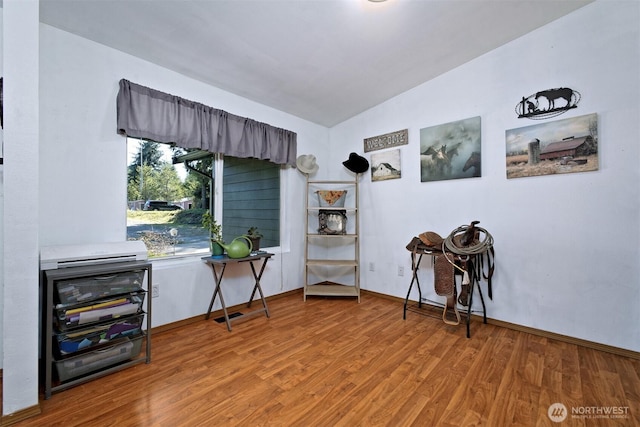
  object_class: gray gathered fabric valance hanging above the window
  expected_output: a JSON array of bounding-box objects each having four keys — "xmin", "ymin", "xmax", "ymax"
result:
[{"xmin": 117, "ymin": 79, "xmax": 297, "ymax": 166}]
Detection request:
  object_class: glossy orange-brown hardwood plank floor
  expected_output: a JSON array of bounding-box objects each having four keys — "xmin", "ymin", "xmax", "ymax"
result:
[{"xmin": 5, "ymin": 293, "xmax": 640, "ymax": 427}]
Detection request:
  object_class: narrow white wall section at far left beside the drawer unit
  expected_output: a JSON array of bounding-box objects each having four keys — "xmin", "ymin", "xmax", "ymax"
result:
[{"xmin": 1, "ymin": 0, "xmax": 39, "ymax": 413}]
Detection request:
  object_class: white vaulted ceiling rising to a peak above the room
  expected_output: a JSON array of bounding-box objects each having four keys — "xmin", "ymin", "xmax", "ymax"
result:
[{"xmin": 40, "ymin": 0, "xmax": 593, "ymax": 127}]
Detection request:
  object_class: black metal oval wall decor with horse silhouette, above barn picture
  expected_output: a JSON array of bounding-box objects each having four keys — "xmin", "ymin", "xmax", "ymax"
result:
[{"xmin": 516, "ymin": 87, "xmax": 580, "ymax": 120}]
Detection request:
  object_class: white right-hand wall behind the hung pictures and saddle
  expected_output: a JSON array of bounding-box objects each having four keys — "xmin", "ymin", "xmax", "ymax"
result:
[{"xmin": 330, "ymin": 1, "xmax": 640, "ymax": 351}]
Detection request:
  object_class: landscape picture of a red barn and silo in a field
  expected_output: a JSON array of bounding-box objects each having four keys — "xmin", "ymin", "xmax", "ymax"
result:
[{"xmin": 505, "ymin": 113, "xmax": 598, "ymax": 178}]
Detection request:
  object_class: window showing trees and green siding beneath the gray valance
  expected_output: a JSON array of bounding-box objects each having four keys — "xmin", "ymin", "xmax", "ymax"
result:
[{"xmin": 127, "ymin": 138, "xmax": 281, "ymax": 258}]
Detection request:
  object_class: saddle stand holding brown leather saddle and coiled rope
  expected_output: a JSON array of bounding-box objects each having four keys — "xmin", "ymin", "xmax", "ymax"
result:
[{"xmin": 403, "ymin": 221, "xmax": 495, "ymax": 338}]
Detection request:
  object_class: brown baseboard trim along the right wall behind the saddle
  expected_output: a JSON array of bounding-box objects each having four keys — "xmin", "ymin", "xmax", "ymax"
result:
[{"xmin": 360, "ymin": 289, "xmax": 640, "ymax": 360}]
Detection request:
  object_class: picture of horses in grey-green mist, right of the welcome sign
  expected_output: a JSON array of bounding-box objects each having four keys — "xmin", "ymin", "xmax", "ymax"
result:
[{"xmin": 420, "ymin": 116, "xmax": 482, "ymax": 182}]
